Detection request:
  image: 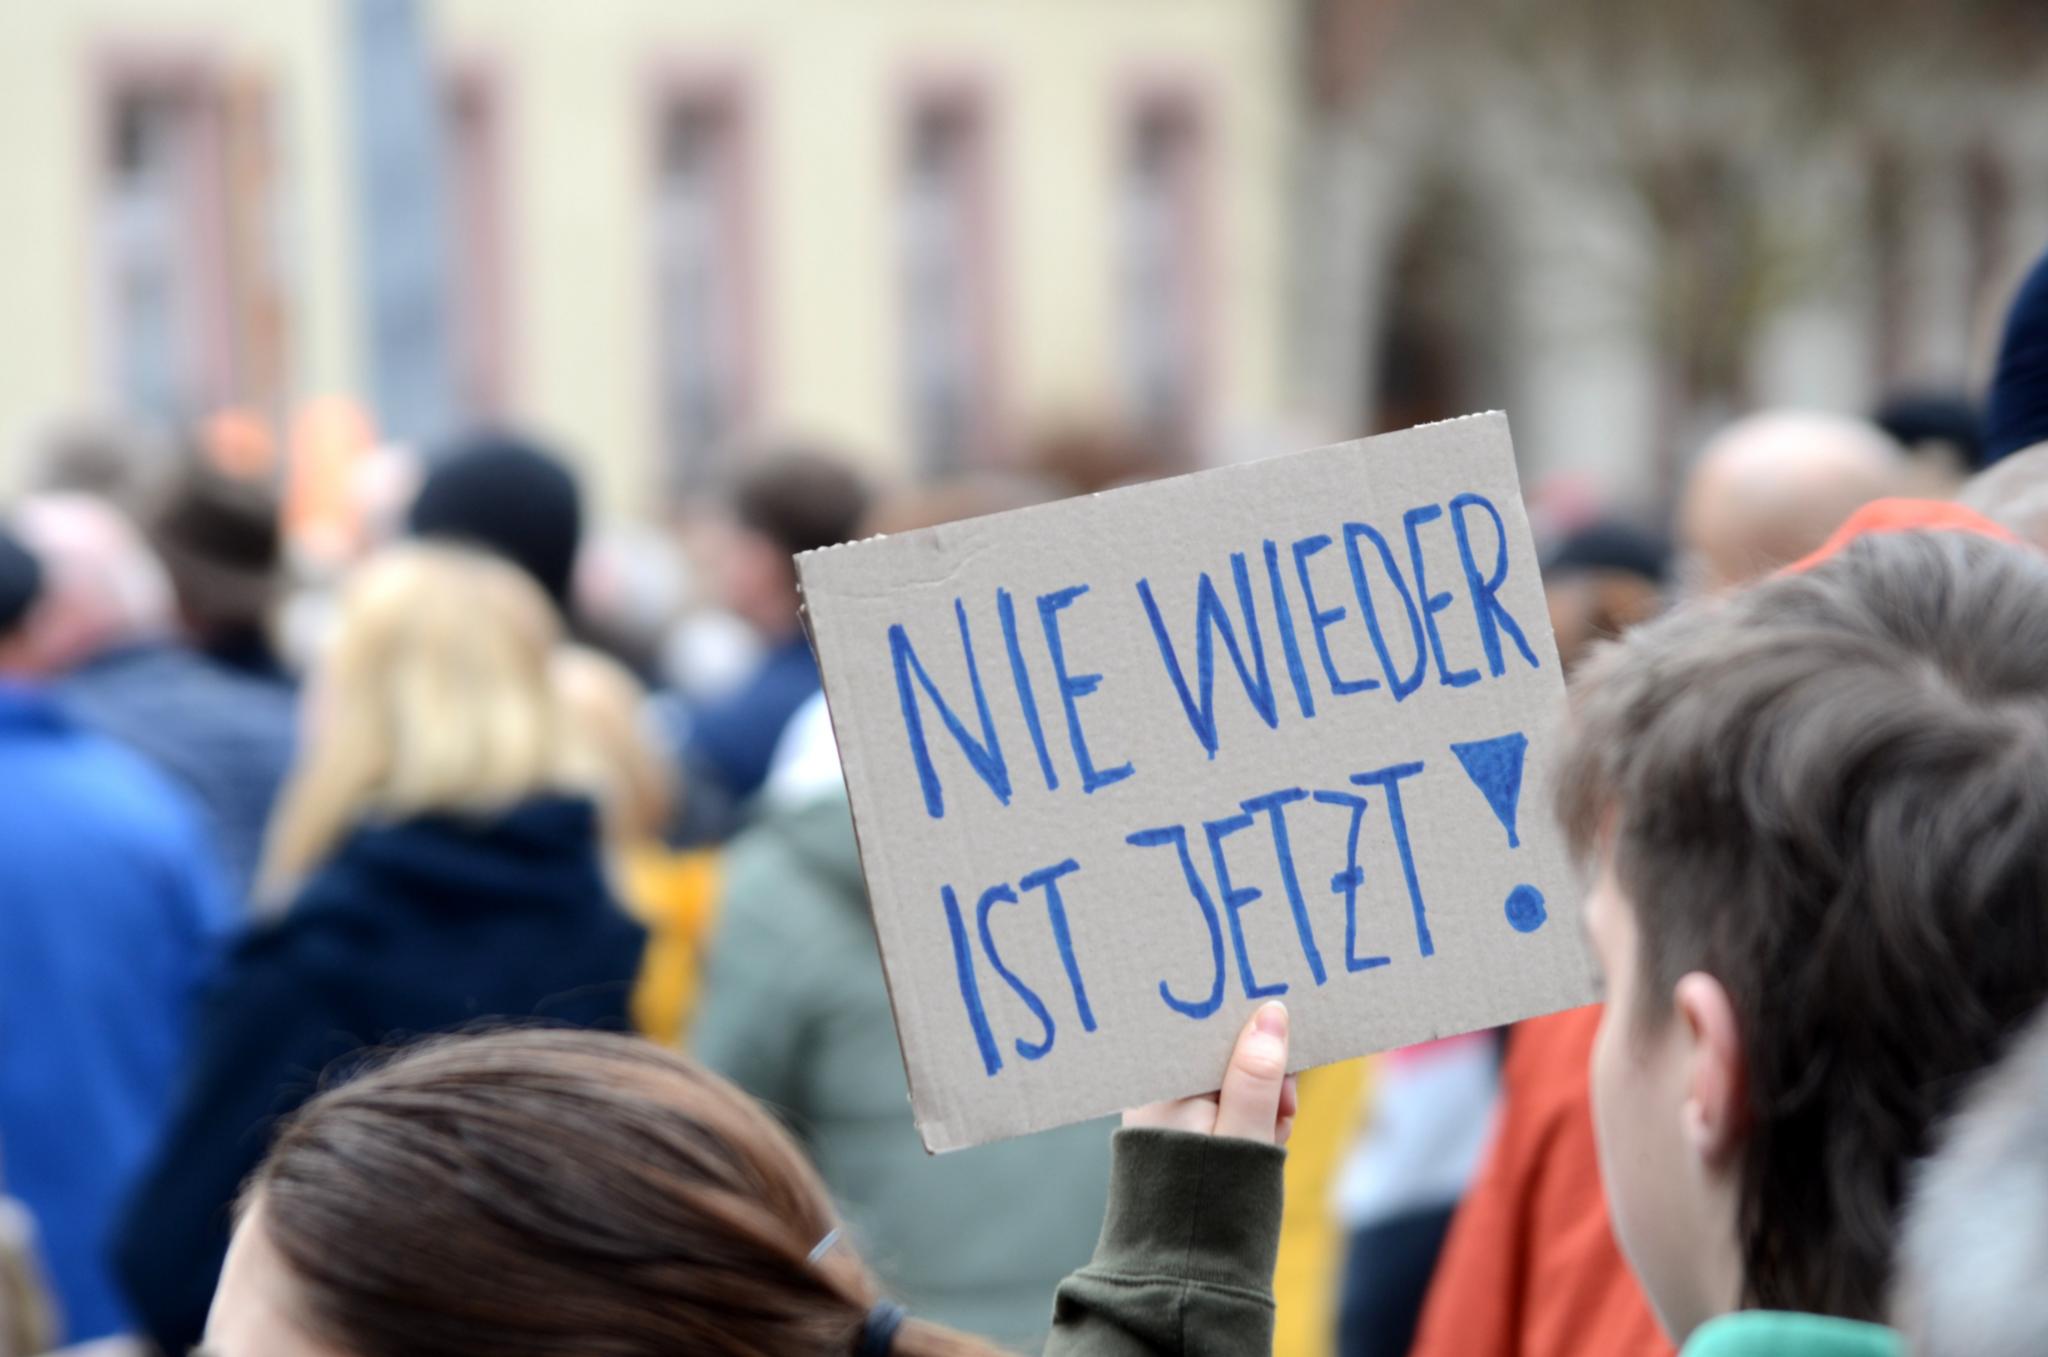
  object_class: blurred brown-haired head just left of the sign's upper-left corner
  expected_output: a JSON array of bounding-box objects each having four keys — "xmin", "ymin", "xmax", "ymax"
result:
[{"xmin": 713, "ymin": 448, "xmax": 868, "ymax": 641}]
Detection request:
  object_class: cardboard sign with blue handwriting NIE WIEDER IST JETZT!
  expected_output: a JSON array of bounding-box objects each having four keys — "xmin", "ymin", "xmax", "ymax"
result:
[{"xmin": 797, "ymin": 413, "xmax": 1593, "ymax": 1150}]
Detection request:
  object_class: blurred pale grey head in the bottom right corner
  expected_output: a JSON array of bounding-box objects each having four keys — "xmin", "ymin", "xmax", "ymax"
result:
[{"xmin": 1892, "ymin": 1002, "xmax": 2048, "ymax": 1357}]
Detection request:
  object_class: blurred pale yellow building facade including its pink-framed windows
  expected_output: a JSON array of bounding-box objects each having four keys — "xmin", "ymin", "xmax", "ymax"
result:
[{"xmin": 0, "ymin": 0, "xmax": 1298, "ymax": 512}]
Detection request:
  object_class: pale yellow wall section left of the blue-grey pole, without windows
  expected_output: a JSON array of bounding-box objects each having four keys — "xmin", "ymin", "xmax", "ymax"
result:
[{"xmin": 0, "ymin": 0, "xmax": 362, "ymax": 485}]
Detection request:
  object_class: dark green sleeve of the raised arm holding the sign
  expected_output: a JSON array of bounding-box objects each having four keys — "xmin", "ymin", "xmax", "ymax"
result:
[{"xmin": 1047, "ymin": 1130, "xmax": 1286, "ymax": 1357}]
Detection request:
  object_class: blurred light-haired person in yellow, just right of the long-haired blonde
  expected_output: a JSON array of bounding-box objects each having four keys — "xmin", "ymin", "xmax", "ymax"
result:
[{"xmin": 555, "ymin": 647, "xmax": 719, "ymax": 1046}]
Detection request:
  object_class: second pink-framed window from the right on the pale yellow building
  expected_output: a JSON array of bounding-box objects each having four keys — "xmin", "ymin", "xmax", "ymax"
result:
[{"xmin": 901, "ymin": 92, "xmax": 991, "ymax": 471}]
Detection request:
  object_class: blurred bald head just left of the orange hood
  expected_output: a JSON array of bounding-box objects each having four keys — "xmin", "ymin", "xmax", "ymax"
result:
[{"xmin": 1677, "ymin": 411, "xmax": 1907, "ymax": 594}]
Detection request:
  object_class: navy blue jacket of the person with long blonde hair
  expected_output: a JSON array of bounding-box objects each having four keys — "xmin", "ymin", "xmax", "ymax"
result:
[{"xmin": 117, "ymin": 798, "xmax": 645, "ymax": 1353}]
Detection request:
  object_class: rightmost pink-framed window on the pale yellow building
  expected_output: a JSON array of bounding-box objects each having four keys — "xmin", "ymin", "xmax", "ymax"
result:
[{"xmin": 1118, "ymin": 94, "xmax": 1206, "ymax": 456}]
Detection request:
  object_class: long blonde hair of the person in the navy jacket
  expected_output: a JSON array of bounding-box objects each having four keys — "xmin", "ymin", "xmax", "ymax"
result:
[{"xmin": 260, "ymin": 544, "xmax": 590, "ymax": 896}]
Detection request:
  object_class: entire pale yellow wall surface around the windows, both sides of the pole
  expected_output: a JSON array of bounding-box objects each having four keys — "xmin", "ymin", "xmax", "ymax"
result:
[{"xmin": 0, "ymin": 0, "xmax": 1294, "ymax": 512}]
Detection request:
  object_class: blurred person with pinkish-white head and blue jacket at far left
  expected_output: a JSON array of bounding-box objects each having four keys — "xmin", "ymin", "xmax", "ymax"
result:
[{"xmin": 14, "ymin": 493, "xmax": 297, "ymax": 899}]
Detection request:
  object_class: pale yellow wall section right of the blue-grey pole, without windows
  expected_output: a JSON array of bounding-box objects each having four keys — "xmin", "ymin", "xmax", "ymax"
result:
[{"xmin": 436, "ymin": 0, "xmax": 1292, "ymax": 510}]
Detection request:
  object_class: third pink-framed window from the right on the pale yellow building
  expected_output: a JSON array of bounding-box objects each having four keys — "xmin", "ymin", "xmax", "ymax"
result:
[{"xmin": 653, "ymin": 92, "xmax": 748, "ymax": 493}]
